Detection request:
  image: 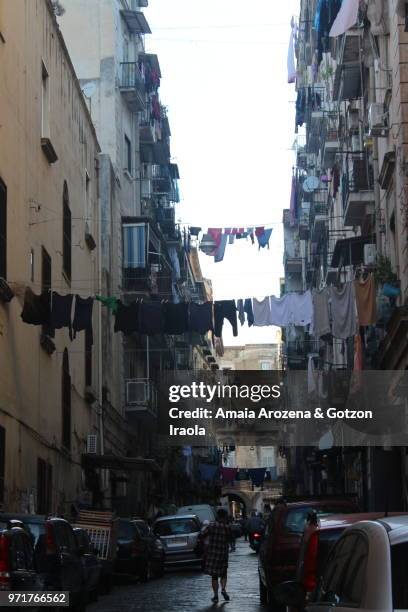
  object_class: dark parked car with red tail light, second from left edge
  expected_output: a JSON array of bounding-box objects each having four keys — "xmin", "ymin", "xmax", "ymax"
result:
[{"xmin": 0, "ymin": 514, "xmax": 87, "ymax": 612}]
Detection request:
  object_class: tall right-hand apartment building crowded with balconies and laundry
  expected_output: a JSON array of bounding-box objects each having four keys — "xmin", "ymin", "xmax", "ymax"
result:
[{"xmin": 283, "ymin": 0, "xmax": 408, "ymax": 508}]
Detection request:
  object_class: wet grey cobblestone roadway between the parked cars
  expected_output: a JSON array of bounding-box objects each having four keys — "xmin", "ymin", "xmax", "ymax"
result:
[{"xmin": 87, "ymin": 538, "xmax": 262, "ymax": 612}]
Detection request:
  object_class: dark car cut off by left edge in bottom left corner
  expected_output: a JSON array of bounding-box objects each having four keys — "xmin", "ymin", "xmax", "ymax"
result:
[{"xmin": 0, "ymin": 520, "xmax": 43, "ymax": 591}]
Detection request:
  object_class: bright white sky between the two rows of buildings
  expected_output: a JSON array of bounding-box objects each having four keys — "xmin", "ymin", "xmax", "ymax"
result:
[{"xmin": 145, "ymin": 0, "xmax": 299, "ymax": 344}]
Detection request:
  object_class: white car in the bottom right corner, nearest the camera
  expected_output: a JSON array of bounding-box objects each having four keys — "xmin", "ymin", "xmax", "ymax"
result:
[{"xmin": 279, "ymin": 515, "xmax": 408, "ymax": 612}]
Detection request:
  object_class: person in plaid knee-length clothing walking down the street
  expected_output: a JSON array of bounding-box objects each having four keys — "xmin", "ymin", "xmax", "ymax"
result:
[{"xmin": 204, "ymin": 508, "xmax": 232, "ymax": 603}]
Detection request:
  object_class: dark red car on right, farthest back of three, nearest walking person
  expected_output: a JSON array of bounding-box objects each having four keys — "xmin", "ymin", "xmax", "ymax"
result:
[{"xmin": 258, "ymin": 497, "xmax": 358, "ymax": 608}]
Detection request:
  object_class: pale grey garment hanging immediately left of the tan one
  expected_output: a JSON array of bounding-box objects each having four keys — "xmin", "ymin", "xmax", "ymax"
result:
[{"xmin": 330, "ymin": 282, "xmax": 357, "ymax": 340}]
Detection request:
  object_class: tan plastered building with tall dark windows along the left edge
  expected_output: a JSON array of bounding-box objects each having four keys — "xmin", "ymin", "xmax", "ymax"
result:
[{"xmin": 0, "ymin": 0, "xmax": 102, "ymax": 513}]
